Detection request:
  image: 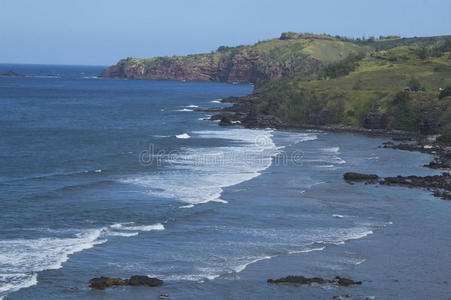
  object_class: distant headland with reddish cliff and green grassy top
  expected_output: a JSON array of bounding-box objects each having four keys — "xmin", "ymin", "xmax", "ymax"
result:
[{"xmin": 101, "ymin": 34, "xmax": 368, "ymax": 84}]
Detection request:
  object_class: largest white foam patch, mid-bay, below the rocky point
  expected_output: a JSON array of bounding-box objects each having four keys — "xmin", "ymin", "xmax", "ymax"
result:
[{"xmin": 121, "ymin": 129, "xmax": 302, "ymax": 204}]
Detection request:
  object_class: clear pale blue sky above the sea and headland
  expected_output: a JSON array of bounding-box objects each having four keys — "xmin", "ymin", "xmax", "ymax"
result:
[{"xmin": 0, "ymin": 0, "xmax": 451, "ymax": 65}]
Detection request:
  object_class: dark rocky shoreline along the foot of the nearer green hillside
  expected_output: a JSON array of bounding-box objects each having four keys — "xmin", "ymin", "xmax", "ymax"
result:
[{"xmin": 201, "ymin": 94, "xmax": 451, "ymax": 200}]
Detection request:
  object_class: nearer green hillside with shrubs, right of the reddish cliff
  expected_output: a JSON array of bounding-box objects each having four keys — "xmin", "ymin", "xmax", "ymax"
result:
[{"xmin": 237, "ymin": 38, "xmax": 451, "ymax": 141}]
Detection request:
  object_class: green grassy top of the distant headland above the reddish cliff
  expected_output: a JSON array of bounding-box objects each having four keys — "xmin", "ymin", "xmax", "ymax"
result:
[{"xmin": 124, "ymin": 35, "xmax": 370, "ymax": 80}]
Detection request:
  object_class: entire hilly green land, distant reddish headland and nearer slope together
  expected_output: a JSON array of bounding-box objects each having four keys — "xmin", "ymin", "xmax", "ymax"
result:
[{"xmin": 102, "ymin": 32, "xmax": 451, "ymax": 142}]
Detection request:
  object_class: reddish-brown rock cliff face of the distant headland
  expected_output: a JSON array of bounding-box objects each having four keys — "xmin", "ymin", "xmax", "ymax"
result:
[{"xmin": 101, "ymin": 52, "xmax": 319, "ymax": 83}]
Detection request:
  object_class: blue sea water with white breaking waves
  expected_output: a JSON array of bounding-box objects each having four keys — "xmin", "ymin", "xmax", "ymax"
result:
[{"xmin": 0, "ymin": 65, "xmax": 450, "ymax": 299}]
